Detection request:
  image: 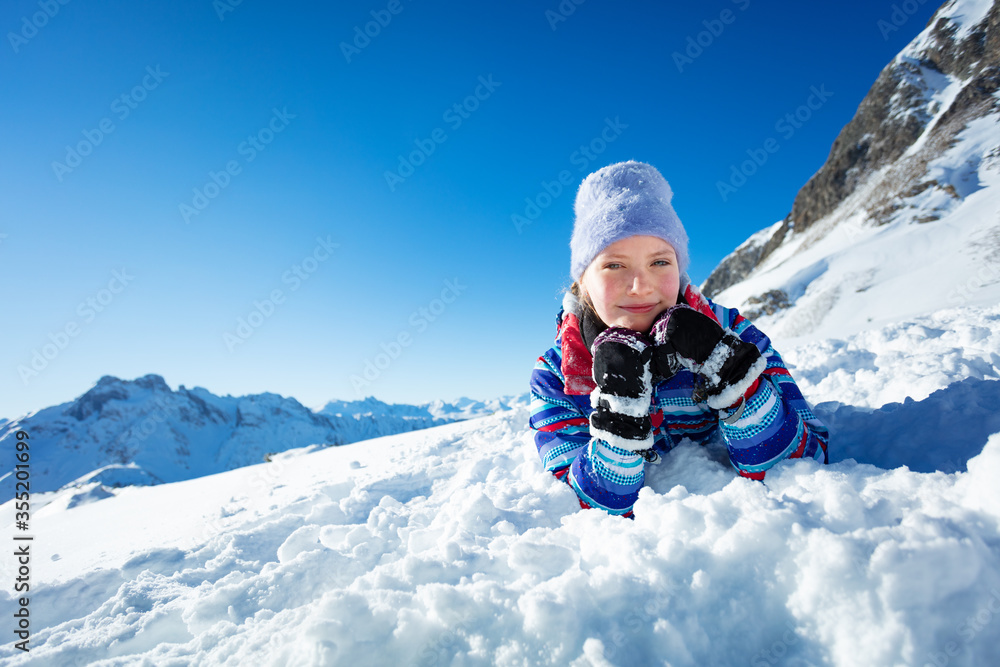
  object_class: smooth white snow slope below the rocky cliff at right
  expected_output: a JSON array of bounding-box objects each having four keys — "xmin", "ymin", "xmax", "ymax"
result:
[{"xmin": 716, "ymin": 116, "xmax": 1000, "ymax": 340}]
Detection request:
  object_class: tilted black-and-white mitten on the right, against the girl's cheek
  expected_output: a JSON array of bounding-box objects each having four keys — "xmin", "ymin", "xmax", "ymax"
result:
[{"xmin": 650, "ymin": 304, "xmax": 767, "ymax": 410}]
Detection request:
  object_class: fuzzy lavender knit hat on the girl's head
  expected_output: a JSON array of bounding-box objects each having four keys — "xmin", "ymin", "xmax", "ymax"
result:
[{"xmin": 569, "ymin": 160, "xmax": 690, "ymax": 282}]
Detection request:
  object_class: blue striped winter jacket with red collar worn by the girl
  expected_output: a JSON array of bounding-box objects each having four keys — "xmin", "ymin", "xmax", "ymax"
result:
[{"xmin": 529, "ymin": 284, "xmax": 829, "ymax": 516}]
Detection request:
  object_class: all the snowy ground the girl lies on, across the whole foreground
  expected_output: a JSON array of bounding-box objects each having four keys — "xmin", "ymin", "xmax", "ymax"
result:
[{"xmin": 0, "ymin": 307, "xmax": 1000, "ymax": 667}]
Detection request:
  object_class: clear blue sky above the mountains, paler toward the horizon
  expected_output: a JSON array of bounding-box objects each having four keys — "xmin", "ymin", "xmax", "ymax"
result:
[{"xmin": 0, "ymin": 0, "xmax": 935, "ymax": 418}]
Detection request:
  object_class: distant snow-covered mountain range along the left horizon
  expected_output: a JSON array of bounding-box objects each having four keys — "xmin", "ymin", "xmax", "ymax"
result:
[{"xmin": 0, "ymin": 375, "xmax": 523, "ymax": 501}]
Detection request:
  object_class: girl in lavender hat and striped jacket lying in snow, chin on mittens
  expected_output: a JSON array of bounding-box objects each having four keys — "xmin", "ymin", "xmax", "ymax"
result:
[{"xmin": 529, "ymin": 161, "xmax": 829, "ymax": 517}]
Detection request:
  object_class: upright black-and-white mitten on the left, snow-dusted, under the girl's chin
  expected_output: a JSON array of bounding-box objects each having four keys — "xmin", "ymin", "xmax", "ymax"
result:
[{"xmin": 590, "ymin": 327, "xmax": 653, "ymax": 451}]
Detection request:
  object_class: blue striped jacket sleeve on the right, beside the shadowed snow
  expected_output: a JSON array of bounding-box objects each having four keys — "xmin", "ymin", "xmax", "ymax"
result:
[{"xmin": 711, "ymin": 304, "xmax": 830, "ymax": 480}]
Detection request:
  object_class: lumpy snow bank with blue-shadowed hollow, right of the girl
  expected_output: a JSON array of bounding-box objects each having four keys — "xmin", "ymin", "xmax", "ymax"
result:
[{"xmin": 785, "ymin": 306, "xmax": 1000, "ymax": 472}]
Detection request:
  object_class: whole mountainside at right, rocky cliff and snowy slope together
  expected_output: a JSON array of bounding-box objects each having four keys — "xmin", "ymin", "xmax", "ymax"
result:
[{"xmin": 703, "ymin": 0, "xmax": 1000, "ymax": 340}]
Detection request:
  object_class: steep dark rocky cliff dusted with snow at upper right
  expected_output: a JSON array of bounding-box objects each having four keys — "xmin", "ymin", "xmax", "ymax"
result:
[{"xmin": 703, "ymin": 0, "xmax": 1000, "ymax": 296}]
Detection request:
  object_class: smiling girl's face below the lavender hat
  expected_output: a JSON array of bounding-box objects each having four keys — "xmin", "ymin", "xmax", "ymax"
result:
[{"xmin": 580, "ymin": 236, "xmax": 680, "ymax": 333}]
